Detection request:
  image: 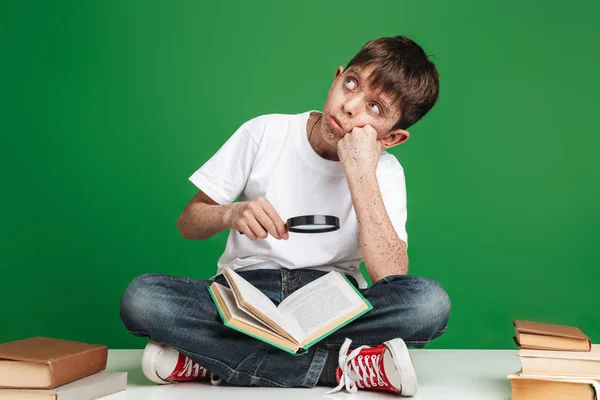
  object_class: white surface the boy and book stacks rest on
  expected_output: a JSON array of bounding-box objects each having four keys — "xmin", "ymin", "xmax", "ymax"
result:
[{"xmin": 102, "ymin": 349, "xmax": 520, "ymax": 400}]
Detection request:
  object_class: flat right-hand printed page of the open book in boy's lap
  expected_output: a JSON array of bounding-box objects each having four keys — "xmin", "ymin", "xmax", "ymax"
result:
[{"xmin": 278, "ymin": 271, "xmax": 364, "ymax": 339}]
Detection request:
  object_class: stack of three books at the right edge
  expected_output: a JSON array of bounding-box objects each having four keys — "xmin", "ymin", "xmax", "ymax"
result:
[{"xmin": 508, "ymin": 320, "xmax": 600, "ymax": 400}]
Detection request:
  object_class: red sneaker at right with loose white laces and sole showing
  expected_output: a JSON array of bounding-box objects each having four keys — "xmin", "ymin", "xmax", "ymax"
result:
[{"xmin": 325, "ymin": 338, "xmax": 417, "ymax": 396}]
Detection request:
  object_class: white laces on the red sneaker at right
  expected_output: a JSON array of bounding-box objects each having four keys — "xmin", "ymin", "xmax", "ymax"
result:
[{"xmin": 325, "ymin": 338, "xmax": 387, "ymax": 395}]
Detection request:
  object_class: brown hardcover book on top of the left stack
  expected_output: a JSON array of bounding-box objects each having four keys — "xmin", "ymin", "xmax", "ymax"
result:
[{"xmin": 0, "ymin": 336, "xmax": 108, "ymax": 389}]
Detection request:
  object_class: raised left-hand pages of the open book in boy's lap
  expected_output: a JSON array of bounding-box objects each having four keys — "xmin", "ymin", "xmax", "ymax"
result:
[{"xmin": 224, "ymin": 268, "xmax": 293, "ymax": 339}]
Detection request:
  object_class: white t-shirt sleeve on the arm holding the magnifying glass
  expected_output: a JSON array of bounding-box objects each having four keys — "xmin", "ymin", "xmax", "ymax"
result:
[{"xmin": 189, "ymin": 120, "xmax": 258, "ymax": 204}]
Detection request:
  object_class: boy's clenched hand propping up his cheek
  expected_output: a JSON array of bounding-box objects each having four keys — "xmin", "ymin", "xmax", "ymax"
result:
[{"xmin": 337, "ymin": 125, "xmax": 383, "ymax": 178}]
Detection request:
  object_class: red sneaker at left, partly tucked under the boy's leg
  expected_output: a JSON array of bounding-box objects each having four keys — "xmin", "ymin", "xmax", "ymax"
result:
[{"xmin": 142, "ymin": 340, "xmax": 221, "ymax": 385}]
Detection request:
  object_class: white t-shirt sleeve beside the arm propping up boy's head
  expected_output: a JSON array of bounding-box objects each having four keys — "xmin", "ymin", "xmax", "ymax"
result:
[{"xmin": 379, "ymin": 164, "xmax": 408, "ymax": 247}]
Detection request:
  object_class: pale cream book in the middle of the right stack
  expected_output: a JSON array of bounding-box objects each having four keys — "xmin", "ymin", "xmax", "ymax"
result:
[{"xmin": 517, "ymin": 344, "xmax": 600, "ymax": 380}]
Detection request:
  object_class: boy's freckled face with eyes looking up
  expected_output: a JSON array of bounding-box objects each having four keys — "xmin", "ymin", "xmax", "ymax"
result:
[{"xmin": 321, "ymin": 66, "xmax": 409, "ymax": 148}]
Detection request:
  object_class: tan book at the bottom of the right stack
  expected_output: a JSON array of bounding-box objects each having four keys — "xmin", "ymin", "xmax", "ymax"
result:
[{"xmin": 508, "ymin": 372, "xmax": 600, "ymax": 400}]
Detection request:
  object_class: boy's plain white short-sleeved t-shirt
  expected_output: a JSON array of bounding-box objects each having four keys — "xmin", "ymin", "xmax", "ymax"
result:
[{"xmin": 189, "ymin": 110, "xmax": 408, "ymax": 288}]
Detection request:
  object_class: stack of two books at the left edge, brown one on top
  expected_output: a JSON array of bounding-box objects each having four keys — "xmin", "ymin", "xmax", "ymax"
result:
[{"xmin": 0, "ymin": 336, "xmax": 127, "ymax": 400}]
